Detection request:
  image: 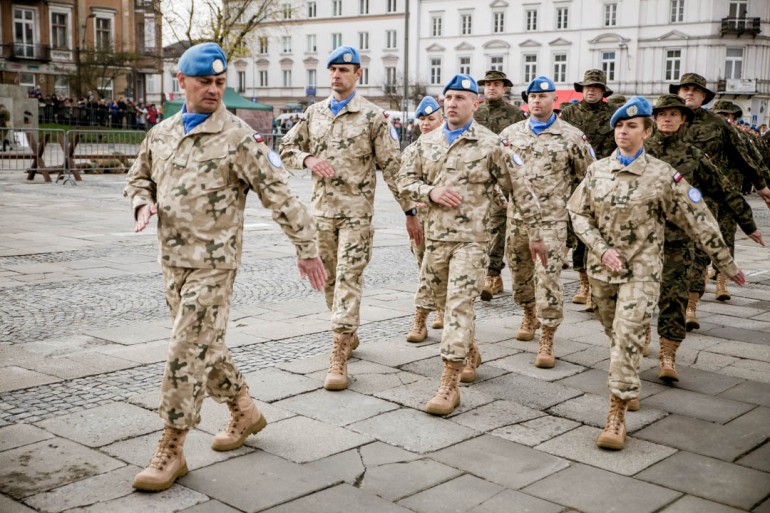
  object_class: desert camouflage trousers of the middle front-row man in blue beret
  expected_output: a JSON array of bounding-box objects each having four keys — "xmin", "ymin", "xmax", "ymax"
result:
[{"xmin": 420, "ymin": 240, "xmax": 489, "ymax": 361}]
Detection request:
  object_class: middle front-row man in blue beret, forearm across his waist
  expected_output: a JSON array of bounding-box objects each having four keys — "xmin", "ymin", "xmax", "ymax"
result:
[{"xmin": 399, "ymin": 75, "xmax": 546, "ymax": 415}]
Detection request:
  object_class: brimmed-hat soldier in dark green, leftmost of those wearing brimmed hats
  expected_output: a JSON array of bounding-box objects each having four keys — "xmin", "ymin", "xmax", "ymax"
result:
[{"xmin": 473, "ymin": 70, "xmax": 527, "ymax": 301}]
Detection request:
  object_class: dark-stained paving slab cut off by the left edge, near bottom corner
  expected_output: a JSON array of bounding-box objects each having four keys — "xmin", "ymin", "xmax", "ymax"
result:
[{"xmin": 0, "ymin": 438, "xmax": 125, "ymax": 499}]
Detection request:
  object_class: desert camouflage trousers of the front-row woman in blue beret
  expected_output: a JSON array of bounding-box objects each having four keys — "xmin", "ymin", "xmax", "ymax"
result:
[{"xmin": 589, "ymin": 276, "xmax": 659, "ymax": 400}]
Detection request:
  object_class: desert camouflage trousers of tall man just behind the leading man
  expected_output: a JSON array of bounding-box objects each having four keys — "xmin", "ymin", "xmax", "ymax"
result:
[{"xmin": 315, "ymin": 217, "xmax": 374, "ymax": 334}]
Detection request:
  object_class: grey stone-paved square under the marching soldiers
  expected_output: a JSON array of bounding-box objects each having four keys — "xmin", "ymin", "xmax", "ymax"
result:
[{"xmin": 0, "ymin": 173, "xmax": 770, "ymax": 513}]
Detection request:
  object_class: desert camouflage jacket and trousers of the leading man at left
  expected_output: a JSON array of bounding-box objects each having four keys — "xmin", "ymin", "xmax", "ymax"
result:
[{"xmin": 124, "ymin": 105, "xmax": 318, "ymax": 429}]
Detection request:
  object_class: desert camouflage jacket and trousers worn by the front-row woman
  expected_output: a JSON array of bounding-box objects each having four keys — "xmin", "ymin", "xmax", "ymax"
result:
[{"xmin": 568, "ymin": 153, "xmax": 738, "ymax": 400}]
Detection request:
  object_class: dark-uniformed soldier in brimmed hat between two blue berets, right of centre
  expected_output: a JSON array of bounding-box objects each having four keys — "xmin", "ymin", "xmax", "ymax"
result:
[{"xmin": 561, "ymin": 69, "xmax": 622, "ymax": 311}]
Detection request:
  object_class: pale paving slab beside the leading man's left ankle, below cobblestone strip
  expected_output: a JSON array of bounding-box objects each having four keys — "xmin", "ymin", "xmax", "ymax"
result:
[{"xmin": 38, "ymin": 403, "xmax": 162, "ymax": 447}]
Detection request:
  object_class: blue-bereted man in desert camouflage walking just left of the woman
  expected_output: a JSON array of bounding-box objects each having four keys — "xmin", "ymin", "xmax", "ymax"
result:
[{"xmin": 500, "ymin": 76, "xmax": 594, "ymax": 368}]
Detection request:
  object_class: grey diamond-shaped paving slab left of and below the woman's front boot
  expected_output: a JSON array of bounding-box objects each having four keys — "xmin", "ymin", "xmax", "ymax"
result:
[{"xmin": 430, "ymin": 435, "xmax": 569, "ymax": 489}]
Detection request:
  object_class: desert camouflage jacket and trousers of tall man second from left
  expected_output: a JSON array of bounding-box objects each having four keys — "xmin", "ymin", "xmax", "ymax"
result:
[{"xmin": 280, "ymin": 93, "xmax": 414, "ymax": 334}]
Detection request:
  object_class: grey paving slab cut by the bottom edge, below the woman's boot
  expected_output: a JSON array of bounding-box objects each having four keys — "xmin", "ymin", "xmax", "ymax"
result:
[{"xmin": 522, "ymin": 464, "xmax": 681, "ymax": 513}]
